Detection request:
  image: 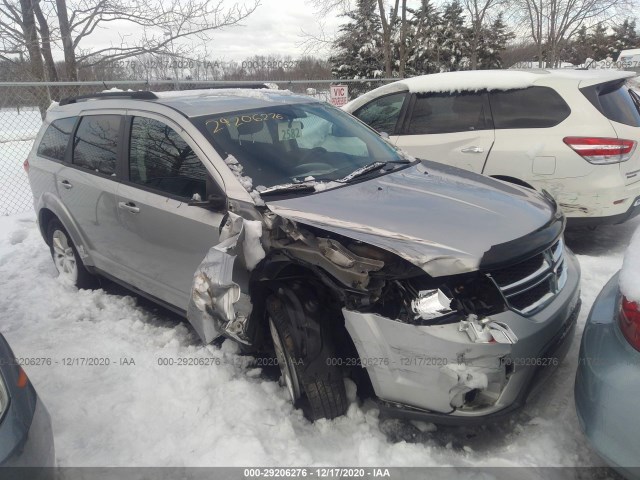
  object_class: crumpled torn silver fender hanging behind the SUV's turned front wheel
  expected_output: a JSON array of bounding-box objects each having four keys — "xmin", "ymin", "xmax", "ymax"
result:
[{"xmin": 187, "ymin": 212, "xmax": 265, "ymax": 344}]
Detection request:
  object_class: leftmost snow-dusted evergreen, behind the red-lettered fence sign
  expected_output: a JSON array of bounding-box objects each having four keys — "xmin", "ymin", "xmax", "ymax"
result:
[{"xmin": 329, "ymin": 0, "xmax": 384, "ymax": 78}]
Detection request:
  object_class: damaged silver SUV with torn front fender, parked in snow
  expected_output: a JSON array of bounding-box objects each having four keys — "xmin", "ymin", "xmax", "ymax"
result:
[{"xmin": 25, "ymin": 89, "xmax": 580, "ymax": 423}]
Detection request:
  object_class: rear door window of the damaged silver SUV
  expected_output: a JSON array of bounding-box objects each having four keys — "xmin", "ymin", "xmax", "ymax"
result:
[{"xmin": 73, "ymin": 115, "xmax": 120, "ymax": 175}]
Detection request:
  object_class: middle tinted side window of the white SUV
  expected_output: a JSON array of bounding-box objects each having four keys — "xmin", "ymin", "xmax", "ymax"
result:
[{"xmin": 407, "ymin": 92, "xmax": 491, "ymax": 135}]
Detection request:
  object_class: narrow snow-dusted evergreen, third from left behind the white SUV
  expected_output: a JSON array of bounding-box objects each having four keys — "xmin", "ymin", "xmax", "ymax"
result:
[{"xmin": 438, "ymin": 0, "xmax": 469, "ymax": 71}]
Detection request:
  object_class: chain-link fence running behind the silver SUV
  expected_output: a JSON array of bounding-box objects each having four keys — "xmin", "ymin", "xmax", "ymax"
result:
[{"xmin": 0, "ymin": 79, "xmax": 390, "ymax": 216}]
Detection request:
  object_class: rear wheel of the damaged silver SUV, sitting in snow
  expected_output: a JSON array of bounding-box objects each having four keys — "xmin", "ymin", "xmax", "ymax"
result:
[{"xmin": 47, "ymin": 218, "xmax": 98, "ymax": 289}]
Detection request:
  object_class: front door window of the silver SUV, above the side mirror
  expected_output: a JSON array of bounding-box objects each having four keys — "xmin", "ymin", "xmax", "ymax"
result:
[{"xmin": 129, "ymin": 117, "xmax": 207, "ymax": 200}]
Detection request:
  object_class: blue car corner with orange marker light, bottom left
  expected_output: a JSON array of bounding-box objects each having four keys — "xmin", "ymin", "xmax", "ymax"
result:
[{"xmin": 0, "ymin": 334, "xmax": 55, "ymax": 479}]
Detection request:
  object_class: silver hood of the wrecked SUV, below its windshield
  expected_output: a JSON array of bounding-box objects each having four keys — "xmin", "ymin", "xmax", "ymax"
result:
[{"xmin": 267, "ymin": 161, "xmax": 562, "ymax": 276}]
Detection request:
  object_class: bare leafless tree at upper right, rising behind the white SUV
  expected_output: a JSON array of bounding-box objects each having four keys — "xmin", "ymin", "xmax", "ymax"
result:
[{"xmin": 517, "ymin": 0, "xmax": 632, "ymax": 67}]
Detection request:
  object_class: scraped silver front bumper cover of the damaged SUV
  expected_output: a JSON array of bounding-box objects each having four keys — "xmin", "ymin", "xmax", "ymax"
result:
[{"xmin": 343, "ymin": 251, "xmax": 580, "ymax": 417}]
